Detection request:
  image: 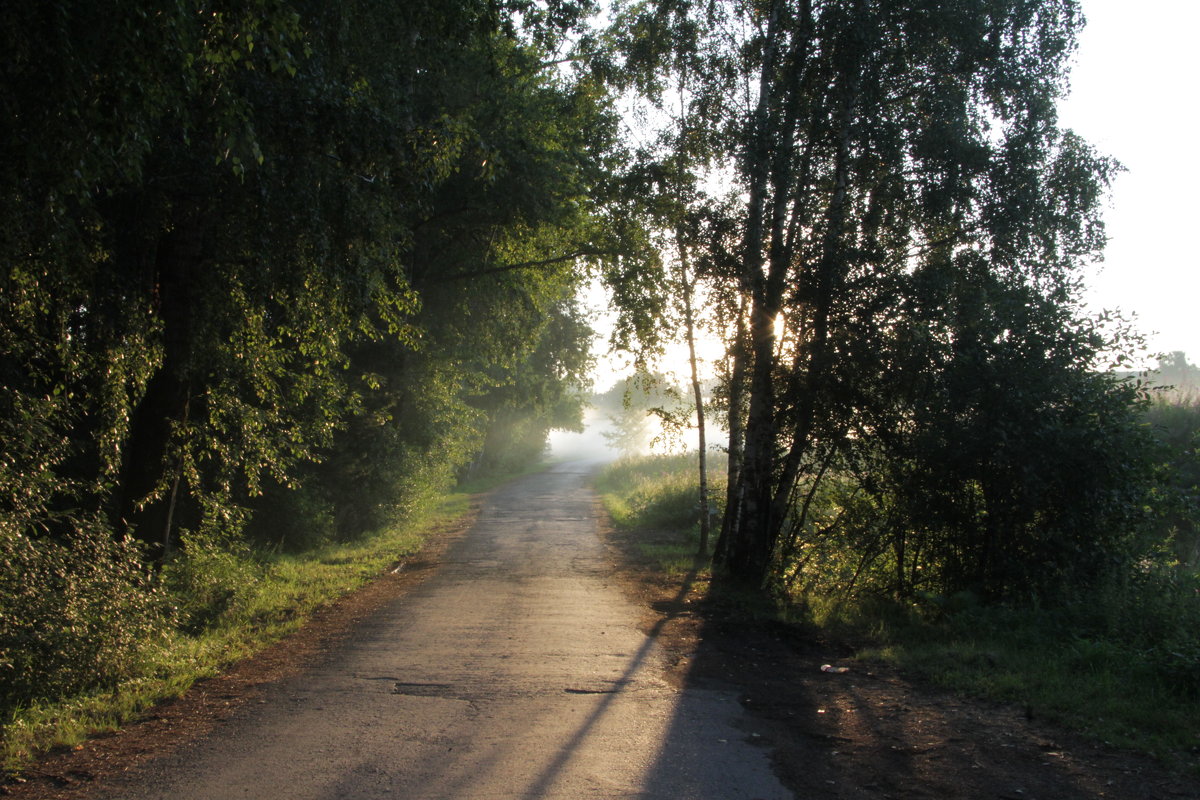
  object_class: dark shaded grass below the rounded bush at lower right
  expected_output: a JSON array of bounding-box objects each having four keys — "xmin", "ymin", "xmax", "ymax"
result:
[{"xmin": 856, "ymin": 594, "xmax": 1200, "ymax": 769}]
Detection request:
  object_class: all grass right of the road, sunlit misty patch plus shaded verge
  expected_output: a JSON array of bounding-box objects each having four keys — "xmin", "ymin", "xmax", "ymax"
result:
[{"xmin": 596, "ymin": 457, "xmax": 1200, "ymax": 770}]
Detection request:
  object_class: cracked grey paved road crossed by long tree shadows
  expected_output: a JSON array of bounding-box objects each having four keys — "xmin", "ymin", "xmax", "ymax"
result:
[{"xmin": 98, "ymin": 464, "xmax": 792, "ymax": 800}]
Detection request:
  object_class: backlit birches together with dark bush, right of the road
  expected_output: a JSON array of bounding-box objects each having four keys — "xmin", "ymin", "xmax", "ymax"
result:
[{"xmin": 604, "ymin": 0, "xmax": 1154, "ymax": 600}]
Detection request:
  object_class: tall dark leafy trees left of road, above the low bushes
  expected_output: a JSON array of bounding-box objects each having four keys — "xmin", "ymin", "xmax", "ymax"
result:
[{"xmin": 0, "ymin": 0, "xmax": 612, "ymax": 555}]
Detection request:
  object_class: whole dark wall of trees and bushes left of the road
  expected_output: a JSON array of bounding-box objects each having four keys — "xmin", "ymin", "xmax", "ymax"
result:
[{"xmin": 0, "ymin": 0, "xmax": 618, "ymax": 709}]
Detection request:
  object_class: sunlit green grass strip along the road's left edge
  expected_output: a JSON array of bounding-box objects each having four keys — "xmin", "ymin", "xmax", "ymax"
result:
[{"xmin": 0, "ymin": 464, "xmax": 520, "ymax": 775}]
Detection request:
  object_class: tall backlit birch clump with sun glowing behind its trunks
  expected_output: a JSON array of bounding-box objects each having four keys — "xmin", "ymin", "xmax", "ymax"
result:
[{"xmin": 626, "ymin": 0, "xmax": 1114, "ymax": 585}]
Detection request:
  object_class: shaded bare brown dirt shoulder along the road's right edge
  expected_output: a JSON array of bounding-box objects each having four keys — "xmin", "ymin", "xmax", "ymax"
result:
[{"xmin": 600, "ymin": 511, "xmax": 1200, "ymax": 800}]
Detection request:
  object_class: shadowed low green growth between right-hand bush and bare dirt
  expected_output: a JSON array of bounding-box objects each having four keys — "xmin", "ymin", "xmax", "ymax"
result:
[{"xmin": 830, "ymin": 575, "xmax": 1200, "ymax": 770}]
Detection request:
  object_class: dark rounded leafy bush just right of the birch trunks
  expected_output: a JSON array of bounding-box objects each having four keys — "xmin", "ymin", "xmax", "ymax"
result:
[{"xmin": 853, "ymin": 278, "xmax": 1154, "ymax": 603}]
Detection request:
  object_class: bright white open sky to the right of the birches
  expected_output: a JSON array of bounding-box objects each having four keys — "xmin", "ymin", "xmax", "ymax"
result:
[{"xmin": 1061, "ymin": 0, "xmax": 1200, "ymax": 363}]
